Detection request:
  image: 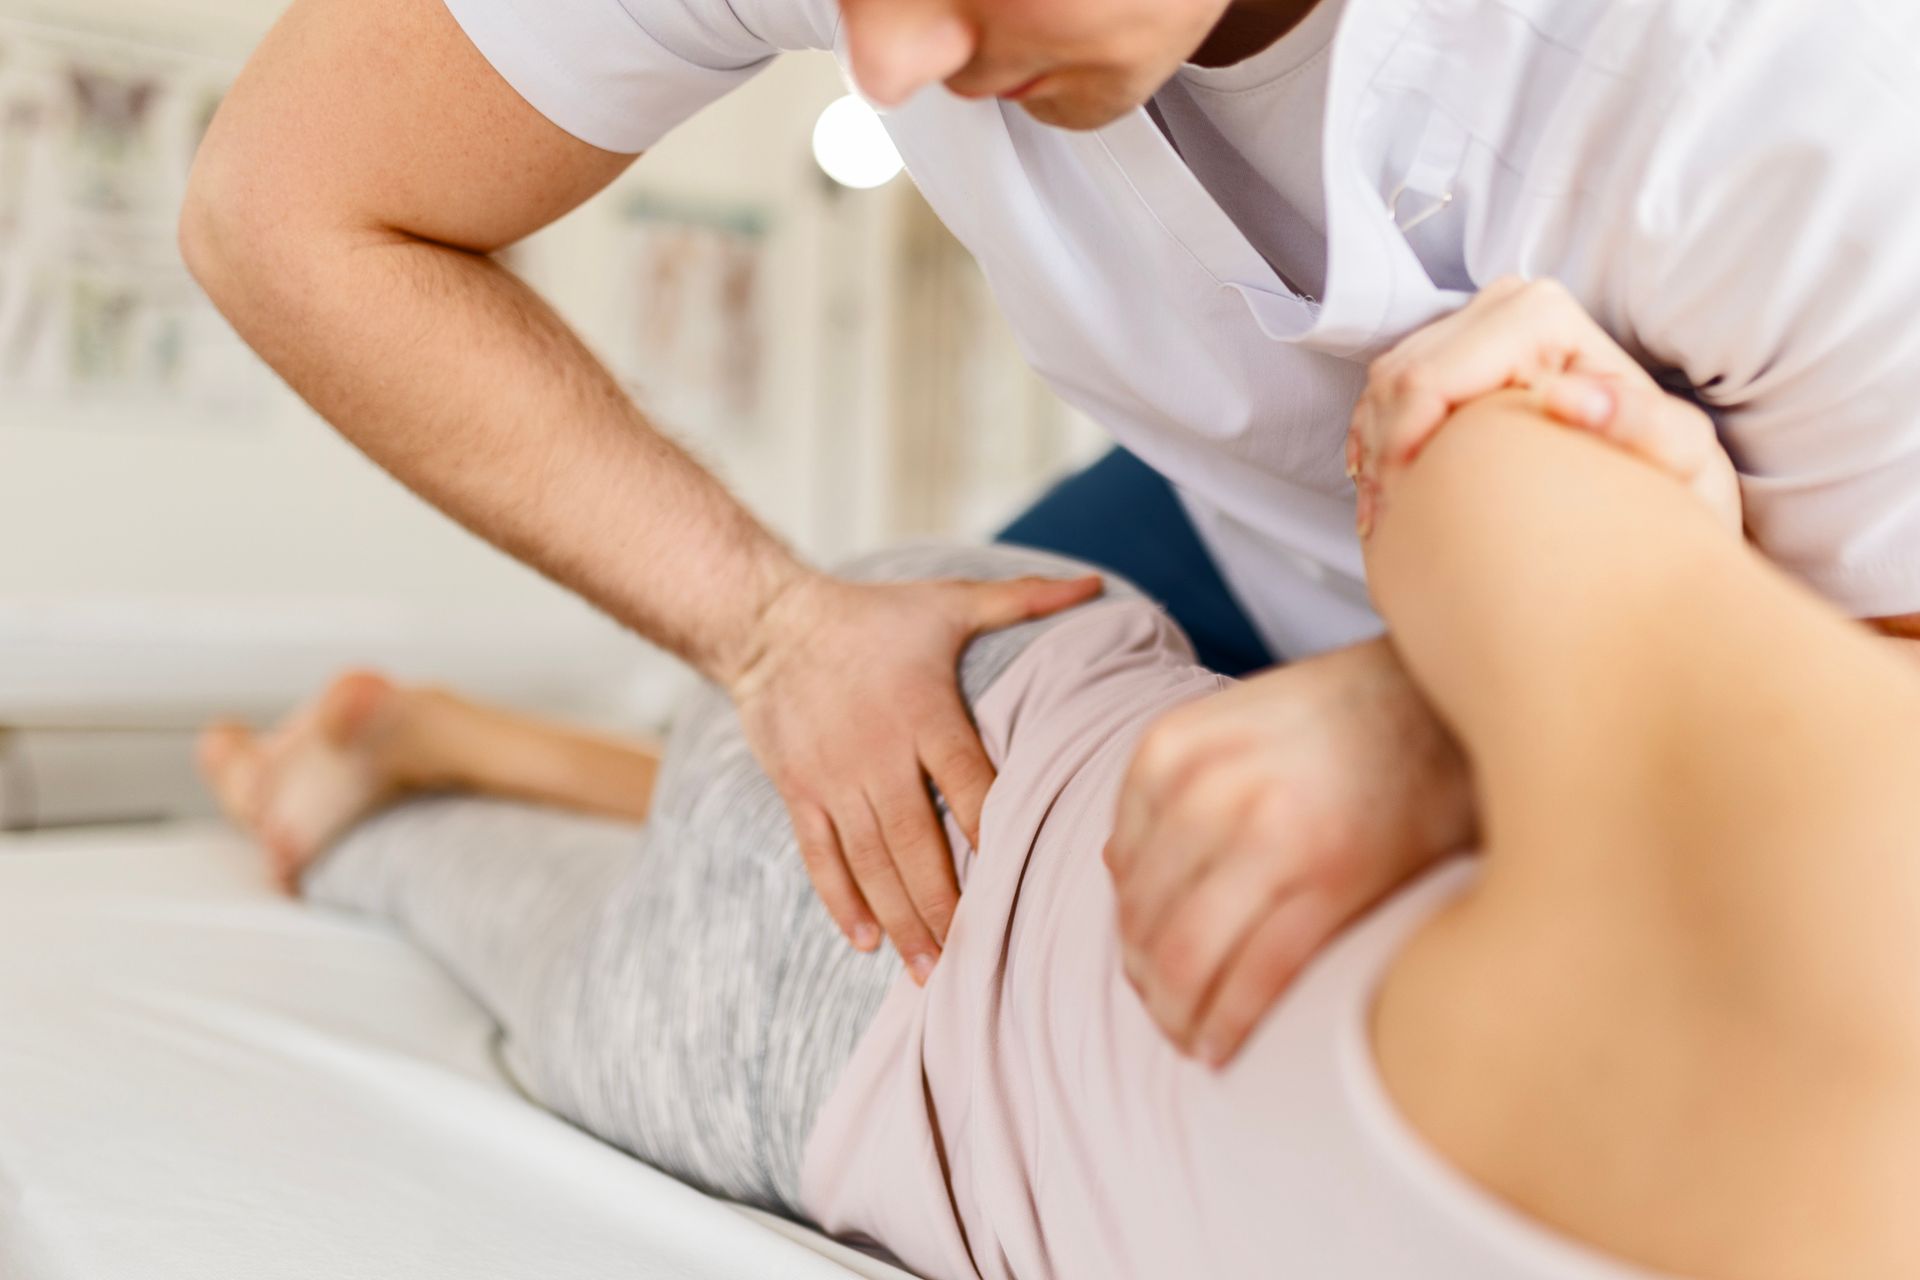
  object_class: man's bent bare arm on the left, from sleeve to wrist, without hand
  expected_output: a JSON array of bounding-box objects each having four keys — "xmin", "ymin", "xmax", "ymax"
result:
[{"xmin": 180, "ymin": 0, "xmax": 801, "ymax": 676}]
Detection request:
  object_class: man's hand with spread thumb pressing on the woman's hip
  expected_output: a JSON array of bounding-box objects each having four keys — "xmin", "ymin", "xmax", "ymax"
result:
[{"xmin": 724, "ymin": 576, "xmax": 1100, "ymax": 983}]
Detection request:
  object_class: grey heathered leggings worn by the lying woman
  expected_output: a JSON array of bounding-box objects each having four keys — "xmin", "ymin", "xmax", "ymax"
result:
[{"xmin": 305, "ymin": 547, "xmax": 1135, "ymax": 1217}]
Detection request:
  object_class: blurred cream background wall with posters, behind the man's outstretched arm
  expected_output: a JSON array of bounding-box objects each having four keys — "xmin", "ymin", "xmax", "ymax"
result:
[{"xmin": 0, "ymin": 0, "xmax": 1100, "ymax": 825}]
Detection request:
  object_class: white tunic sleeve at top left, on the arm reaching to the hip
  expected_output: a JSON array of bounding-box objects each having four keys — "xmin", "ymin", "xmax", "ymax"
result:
[{"xmin": 445, "ymin": 0, "xmax": 835, "ymax": 154}]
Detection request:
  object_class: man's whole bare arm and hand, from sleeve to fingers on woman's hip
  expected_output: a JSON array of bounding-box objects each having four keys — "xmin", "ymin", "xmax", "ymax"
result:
[{"xmin": 180, "ymin": 0, "xmax": 1098, "ymax": 977}]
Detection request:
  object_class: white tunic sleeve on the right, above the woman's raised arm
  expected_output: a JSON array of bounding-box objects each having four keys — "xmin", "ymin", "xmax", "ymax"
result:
[{"xmin": 1628, "ymin": 0, "xmax": 1920, "ymax": 618}]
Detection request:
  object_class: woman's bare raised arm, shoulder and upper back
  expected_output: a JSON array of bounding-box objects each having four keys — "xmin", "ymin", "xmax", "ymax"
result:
[{"xmin": 1369, "ymin": 395, "xmax": 1920, "ymax": 1280}]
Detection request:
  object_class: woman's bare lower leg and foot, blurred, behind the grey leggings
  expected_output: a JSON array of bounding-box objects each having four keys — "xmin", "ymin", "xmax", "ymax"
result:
[{"xmin": 200, "ymin": 672, "xmax": 660, "ymax": 879}]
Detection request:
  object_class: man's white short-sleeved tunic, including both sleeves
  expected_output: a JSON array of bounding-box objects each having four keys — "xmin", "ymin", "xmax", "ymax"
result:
[{"xmin": 447, "ymin": 0, "xmax": 1920, "ymax": 656}]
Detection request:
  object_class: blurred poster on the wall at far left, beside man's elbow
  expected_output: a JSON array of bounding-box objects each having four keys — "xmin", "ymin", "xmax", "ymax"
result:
[{"xmin": 0, "ymin": 17, "xmax": 273, "ymax": 426}]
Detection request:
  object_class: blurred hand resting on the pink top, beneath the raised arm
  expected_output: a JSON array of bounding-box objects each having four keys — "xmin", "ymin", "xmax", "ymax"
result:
[{"xmin": 1106, "ymin": 641, "xmax": 1473, "ymax": 1065}]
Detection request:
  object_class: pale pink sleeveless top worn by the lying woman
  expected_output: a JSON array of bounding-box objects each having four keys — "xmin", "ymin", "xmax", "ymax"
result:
[{"xmin": 803, "ymin": 601, "xmax": 1642, "ymax": 1280}]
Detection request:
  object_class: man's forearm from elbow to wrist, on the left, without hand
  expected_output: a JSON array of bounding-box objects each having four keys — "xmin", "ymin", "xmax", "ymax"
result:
[{"xmin": 182, "ymin": 225, "xmax": 806, "ymax": 679}]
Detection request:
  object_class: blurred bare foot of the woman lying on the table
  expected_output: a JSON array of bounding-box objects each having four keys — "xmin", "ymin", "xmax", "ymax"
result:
[{"xmin": 200, "ymin": 672, "xmax": 451, "ymax": 889}]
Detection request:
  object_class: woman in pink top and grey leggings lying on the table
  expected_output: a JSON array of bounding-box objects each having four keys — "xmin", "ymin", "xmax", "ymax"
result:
[{"xmin": 204, "ymin": 293, "xmax": 1920, "ymax": 1280}]
